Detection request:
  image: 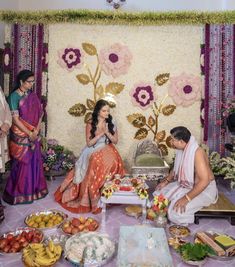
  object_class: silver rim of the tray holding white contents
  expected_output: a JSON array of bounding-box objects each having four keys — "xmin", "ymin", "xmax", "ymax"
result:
[{"xmin": 64, "ymin": 232, "xmax": 117, "ymax": 267}]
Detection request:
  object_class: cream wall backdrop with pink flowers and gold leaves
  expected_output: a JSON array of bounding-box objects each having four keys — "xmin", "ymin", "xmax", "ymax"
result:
[{"xmin": 47, "ymin": 24, "xmax": 202, "ymax": 170}]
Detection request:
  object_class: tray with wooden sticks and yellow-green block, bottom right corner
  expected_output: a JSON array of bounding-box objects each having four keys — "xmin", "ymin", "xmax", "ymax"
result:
[{"xmin": 194, "ymin": 231, "xmax": 235, "ymax": 261}]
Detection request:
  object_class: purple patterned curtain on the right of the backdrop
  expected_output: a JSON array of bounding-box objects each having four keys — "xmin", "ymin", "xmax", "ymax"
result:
[{"xmin": 201, "ymin": 25, "xmax": 235, "ymax": 155}]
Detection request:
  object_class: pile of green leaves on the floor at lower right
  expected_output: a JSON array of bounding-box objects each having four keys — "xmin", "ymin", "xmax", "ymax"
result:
[{"xmin": 179, "ymin": 243, "xmax": 215, "ymax": 261}]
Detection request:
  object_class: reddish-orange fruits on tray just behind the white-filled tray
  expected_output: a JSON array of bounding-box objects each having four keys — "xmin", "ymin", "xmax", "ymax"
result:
[{"xmin": 61, "ymin": 217, "xmax": 99, "ymax": 235}]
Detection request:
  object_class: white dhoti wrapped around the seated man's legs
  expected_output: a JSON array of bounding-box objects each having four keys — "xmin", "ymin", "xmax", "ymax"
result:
[{"xmin": 153, "ymin": 180, "xmax": 218, "ymax": 225}]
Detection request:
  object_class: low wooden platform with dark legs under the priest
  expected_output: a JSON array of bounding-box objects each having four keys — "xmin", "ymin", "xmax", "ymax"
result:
[{"xmin": 194, "ymin": 193, "xmax": 235, "ymax": 225}]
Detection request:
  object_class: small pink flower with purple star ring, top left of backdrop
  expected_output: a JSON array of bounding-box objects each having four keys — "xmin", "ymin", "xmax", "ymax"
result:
[{"xmin": 57, "ymin": 46, "xmax": 83, "ymax": 71}]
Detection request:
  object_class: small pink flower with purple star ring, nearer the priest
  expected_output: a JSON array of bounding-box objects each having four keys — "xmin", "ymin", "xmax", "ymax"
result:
[{"xmin": 130, "ymin": 83, "xmax": 155, "ymax": 109}]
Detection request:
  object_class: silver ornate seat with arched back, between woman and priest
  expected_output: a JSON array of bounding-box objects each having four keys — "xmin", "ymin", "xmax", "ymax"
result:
[{"xmin": 131, "ymin": 139, "xmax": 169, "ymax": 181}]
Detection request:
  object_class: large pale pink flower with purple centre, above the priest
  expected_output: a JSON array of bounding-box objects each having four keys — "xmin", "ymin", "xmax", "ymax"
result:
[{"xmin": 168, "ymin": 73, "xmax": 202, "ymax": 107}]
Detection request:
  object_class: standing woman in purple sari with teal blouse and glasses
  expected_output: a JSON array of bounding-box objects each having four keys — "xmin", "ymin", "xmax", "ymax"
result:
[{"xmin": 3, "ymin": 70, "xmax": 48, "ymax": 205}]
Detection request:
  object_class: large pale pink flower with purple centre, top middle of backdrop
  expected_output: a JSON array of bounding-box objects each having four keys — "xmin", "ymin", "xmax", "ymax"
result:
[{"xmin": 99, "ymin": 43, "xmax": 132, "ymax": 78}]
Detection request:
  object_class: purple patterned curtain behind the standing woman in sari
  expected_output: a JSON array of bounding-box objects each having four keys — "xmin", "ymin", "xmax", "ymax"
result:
[{"xmin": 4, "ymin": 24, "xmax": 48, "ymax": 135}]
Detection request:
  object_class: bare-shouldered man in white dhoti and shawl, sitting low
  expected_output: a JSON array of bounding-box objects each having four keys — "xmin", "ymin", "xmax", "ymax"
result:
[{"xmin": 154, "ymin": 126, "xmax": 218, "ymax": 225}]
